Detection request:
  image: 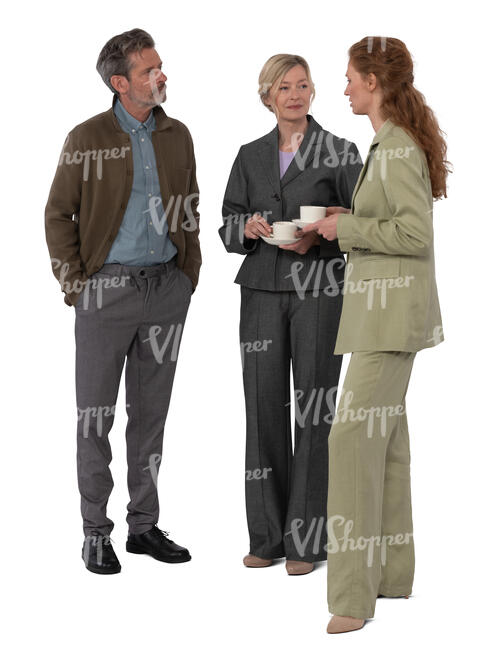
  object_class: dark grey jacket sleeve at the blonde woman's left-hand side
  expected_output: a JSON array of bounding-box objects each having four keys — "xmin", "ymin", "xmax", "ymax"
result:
[{"xmin": 218, "ymin": 147, "xmax": 259, "ymax": 255}]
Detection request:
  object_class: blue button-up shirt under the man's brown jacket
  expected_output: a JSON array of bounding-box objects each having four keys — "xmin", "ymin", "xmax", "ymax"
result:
[{"xmin": 104, "ymin": 100, "xmax": 178, "ymax": 266}]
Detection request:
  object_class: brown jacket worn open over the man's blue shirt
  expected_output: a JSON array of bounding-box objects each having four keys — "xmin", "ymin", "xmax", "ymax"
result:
[{"xmin": 45, "ymin": 95, "xmax": 202, "ymax": 305}]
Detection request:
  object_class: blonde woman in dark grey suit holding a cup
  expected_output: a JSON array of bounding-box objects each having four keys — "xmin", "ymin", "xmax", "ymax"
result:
[{"xmin": 220, "ymin": 54, "xmax": 362, "ymax": 575}]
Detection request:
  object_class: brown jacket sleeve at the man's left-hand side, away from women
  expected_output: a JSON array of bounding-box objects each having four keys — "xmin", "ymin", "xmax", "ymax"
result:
[{"xmin": 45, "ymin": 131, "xmax": 87, "ymax": 305}]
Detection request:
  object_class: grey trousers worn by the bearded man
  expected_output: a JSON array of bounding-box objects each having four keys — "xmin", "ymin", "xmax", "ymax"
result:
[{"xmin": 75, "ymin": 259, "xmax": 192, "ymax": 535}]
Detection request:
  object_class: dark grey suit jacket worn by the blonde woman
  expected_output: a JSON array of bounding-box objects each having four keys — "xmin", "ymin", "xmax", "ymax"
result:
[{"xmin": 219, "ymin": 115, "xmax": 362, "ymax": 291}]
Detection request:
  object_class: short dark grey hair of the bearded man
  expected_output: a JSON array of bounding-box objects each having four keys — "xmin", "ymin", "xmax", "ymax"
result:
[{"xmin": 96, "ymin": 29, "xmax": 155, "ymax": 95}]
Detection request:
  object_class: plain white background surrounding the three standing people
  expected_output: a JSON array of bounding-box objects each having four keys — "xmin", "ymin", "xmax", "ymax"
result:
[{"xmin": 0, "ymin": 0, "xmax": 502, "ymax": 649}]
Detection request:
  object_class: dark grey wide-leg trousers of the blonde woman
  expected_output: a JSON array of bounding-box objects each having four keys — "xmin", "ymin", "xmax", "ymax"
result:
[{"xmin": 240, "ymin": 286, "xmax": 342, "ymax": 562}]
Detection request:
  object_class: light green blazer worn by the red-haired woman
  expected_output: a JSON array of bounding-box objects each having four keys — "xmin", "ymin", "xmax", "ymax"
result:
[{"xmin": 334, "ymin": 120, "xmax": 444, "ymax": 354}]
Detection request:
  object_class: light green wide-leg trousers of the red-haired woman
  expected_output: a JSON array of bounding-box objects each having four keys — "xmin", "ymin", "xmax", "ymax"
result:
[{"xmin": 327, "ymin": 352, "xmax": 416, "ymax": 618}]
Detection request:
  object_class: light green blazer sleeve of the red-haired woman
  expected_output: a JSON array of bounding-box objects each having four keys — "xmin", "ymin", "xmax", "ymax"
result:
[{"xmin": 337, "ymin": 138, "xmax": 433, "ymax": 255}]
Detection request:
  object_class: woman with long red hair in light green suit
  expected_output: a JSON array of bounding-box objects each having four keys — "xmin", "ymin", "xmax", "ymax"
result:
[{"xmin": 303, "ymin": 37, "xmax": 449, "ymax": 633}]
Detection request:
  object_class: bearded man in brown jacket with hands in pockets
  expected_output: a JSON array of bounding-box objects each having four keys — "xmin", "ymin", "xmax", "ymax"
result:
[{"xmin": 45, "ymin": 29, "xmax": 201, "ymax": 574}]
